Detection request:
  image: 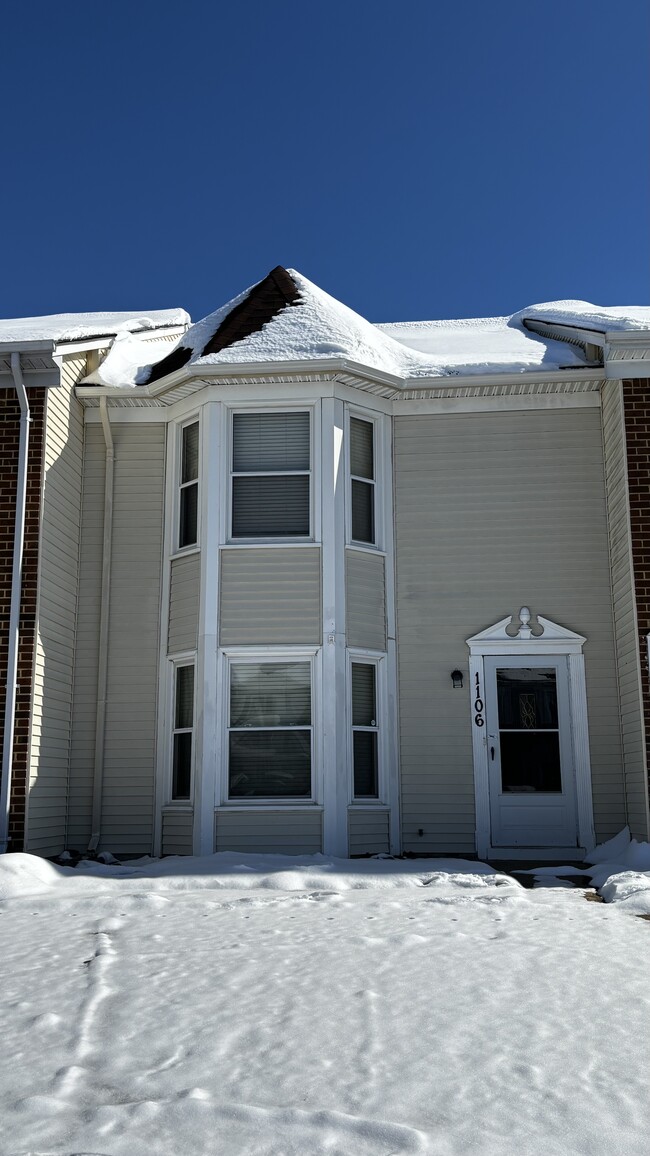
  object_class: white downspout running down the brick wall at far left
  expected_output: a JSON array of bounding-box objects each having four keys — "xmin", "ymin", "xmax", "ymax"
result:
[{"xmin": 0, "ymin": 353, "xmax": 31, "ymax": 854}]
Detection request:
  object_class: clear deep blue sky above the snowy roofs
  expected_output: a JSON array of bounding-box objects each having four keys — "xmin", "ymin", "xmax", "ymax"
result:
[{"xmin": 0, "ymin": 0, "xmax": 650, "ymax": 321}]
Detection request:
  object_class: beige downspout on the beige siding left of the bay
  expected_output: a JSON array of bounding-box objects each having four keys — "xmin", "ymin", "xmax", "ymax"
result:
[{"xmin": 88, "ymin": 398, "xmax": 115, "ymax": 851}]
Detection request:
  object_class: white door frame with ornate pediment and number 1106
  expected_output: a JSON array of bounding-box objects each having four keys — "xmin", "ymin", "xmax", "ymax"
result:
[{"xmin": 466, "ymin": 606, "xmax": 596, "ymax": 861}]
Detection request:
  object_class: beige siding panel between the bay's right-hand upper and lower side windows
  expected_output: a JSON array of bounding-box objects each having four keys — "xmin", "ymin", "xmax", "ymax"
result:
[{"xmin": 346, "ymin": 549, "xmax": 386, "ymax": 650}]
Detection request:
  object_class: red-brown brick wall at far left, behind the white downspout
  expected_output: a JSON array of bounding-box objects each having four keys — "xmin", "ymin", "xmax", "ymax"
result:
[{"xmin": 0, "ymin": 388, "xmax": 45, "ymax": 851}]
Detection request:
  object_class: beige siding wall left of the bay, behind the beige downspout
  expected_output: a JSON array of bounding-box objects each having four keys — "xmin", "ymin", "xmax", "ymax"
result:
[{"xmin": 68, "ymin": 423, "xmax": 164, "ymax": 853}]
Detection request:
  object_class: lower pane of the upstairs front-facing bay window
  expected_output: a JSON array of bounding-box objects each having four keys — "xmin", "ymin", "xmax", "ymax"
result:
[{"xmin": 232, "ymin": 474, "xmax": 309, "ymax": 538}]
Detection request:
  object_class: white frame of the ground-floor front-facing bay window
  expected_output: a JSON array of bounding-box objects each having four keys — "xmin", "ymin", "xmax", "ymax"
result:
[{"xmin": 215, "ymin": 646, "xmax": 323, "ymax": 812}]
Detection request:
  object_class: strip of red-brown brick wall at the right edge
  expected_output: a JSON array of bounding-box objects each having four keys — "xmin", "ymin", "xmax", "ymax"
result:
[{"xmin": 623, "ymin": 378, "xmax": 650, "ymax": 765}]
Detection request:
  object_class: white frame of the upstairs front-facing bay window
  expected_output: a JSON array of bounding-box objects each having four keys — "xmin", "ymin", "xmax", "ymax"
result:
[{"xmin": 223, "ymin": 401, "xmax": 320, "ymax": 547}]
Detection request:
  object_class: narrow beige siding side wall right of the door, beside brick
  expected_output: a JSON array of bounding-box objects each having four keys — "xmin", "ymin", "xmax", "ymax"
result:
[{"xmin": 603, "ymin": 381, "xmax": 648, "ymax": 839}]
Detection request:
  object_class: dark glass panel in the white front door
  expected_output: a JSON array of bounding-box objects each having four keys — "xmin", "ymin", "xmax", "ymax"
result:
[{"xmin": 496, "ymin": 666, "xmax": 562, "ymax": 794}]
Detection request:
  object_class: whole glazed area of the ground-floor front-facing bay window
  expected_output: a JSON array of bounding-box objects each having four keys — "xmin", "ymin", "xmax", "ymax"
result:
[{"xmin": 228, "ymin": 659, "xmax": 313, "ymax": 800}]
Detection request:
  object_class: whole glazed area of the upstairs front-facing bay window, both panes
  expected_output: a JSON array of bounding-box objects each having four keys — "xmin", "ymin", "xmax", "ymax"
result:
[{"xmin": 232, "ymin": 410, "xmax": 311, "ymax": 538}]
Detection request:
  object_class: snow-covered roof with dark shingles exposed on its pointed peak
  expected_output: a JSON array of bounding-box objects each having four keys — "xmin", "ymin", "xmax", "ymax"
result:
[{"xmin": 71, "ymin": 266, "xmax": 650, "ymax": 386}]
